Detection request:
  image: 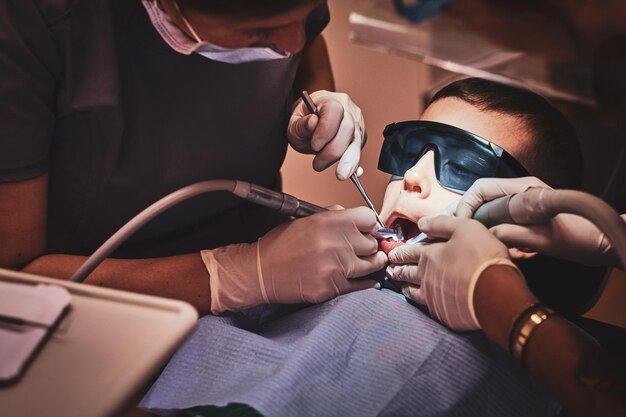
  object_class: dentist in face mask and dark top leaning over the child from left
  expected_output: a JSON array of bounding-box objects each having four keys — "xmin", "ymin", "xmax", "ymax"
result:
[{"xmin": 0, "ymin": 0, "xmax": 386, "ymax": 313}]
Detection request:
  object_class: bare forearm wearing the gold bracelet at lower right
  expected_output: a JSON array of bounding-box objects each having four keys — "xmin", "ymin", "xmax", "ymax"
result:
[{"xmin": 474, "ymin": 266, "xmax": 626, "ymax": 416}]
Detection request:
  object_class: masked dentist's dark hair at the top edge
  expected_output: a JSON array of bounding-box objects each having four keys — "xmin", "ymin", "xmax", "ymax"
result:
[{"xmin": 178, "ymin": 0, "xmax": 312, "ymax": 18}]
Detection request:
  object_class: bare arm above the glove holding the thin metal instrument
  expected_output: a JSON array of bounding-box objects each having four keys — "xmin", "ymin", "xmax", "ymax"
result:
[{"xmin": 293, "ymin": 35, "xmax": 335, "ymax": 97}]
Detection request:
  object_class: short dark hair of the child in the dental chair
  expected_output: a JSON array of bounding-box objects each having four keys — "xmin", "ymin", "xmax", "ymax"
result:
[{"xmin": 429, "ymin": 78, "xmax": 583, "ymax": 189}]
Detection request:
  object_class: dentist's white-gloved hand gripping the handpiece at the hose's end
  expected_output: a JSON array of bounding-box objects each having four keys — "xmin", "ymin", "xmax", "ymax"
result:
[{"xmin": 201, "ymin": 207, "xmax": 387, "ymax": 314}]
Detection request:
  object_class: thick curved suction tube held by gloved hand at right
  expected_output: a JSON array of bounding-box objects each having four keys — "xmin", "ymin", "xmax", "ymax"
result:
[{"xmin": 474, "ymin": 187, "xmax": 626, "ymax": 267}]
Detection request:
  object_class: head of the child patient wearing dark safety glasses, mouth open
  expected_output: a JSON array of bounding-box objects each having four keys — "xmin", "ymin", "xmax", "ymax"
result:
[{"xmin": 370, "ymin": 78, "xmax": 582, "ymax": 255}]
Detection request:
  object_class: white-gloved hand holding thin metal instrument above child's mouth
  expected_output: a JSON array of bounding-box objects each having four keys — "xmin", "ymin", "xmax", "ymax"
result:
[{"xmin": 287, "ymin": 90, "xmax": 367, "ymax": 180}]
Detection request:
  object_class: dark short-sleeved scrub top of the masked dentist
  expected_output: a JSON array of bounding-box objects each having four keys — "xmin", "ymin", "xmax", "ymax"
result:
[{"xmin": 0, "ymin": 0, "xmax": 328, "ymax": 257}]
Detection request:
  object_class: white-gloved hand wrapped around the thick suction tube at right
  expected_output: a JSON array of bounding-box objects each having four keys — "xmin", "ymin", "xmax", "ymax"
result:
[{"xmin": 452, "ymin": 177, "xmax": 626, "ymax": 267}]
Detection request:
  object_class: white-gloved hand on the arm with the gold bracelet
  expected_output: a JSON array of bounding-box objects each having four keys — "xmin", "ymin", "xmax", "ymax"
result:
[{"xmin": 387, "ymin": 216, "xmax": 521, "ymax": 330}]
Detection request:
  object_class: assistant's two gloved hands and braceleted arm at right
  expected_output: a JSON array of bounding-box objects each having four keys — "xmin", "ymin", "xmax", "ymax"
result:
[{"xmin": 387, "ymin": 177, "xmax": 626, "ymax": 416}]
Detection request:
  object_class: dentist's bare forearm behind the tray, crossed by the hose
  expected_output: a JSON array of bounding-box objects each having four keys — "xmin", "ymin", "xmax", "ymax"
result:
[{"xmin": 23, "ymin": 253, "xmax": 211, "ymax": 314}]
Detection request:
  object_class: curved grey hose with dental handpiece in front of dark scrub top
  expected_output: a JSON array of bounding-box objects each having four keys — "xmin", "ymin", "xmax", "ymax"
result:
[{"xmin": 70, "ymin": 180, "xmax": 326, "ymax": 282}]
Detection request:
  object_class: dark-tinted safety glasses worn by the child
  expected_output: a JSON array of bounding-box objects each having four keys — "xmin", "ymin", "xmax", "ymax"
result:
[{"xmin": 378, "ymin": 120, "xmax": 530, "ymax": 194}]
